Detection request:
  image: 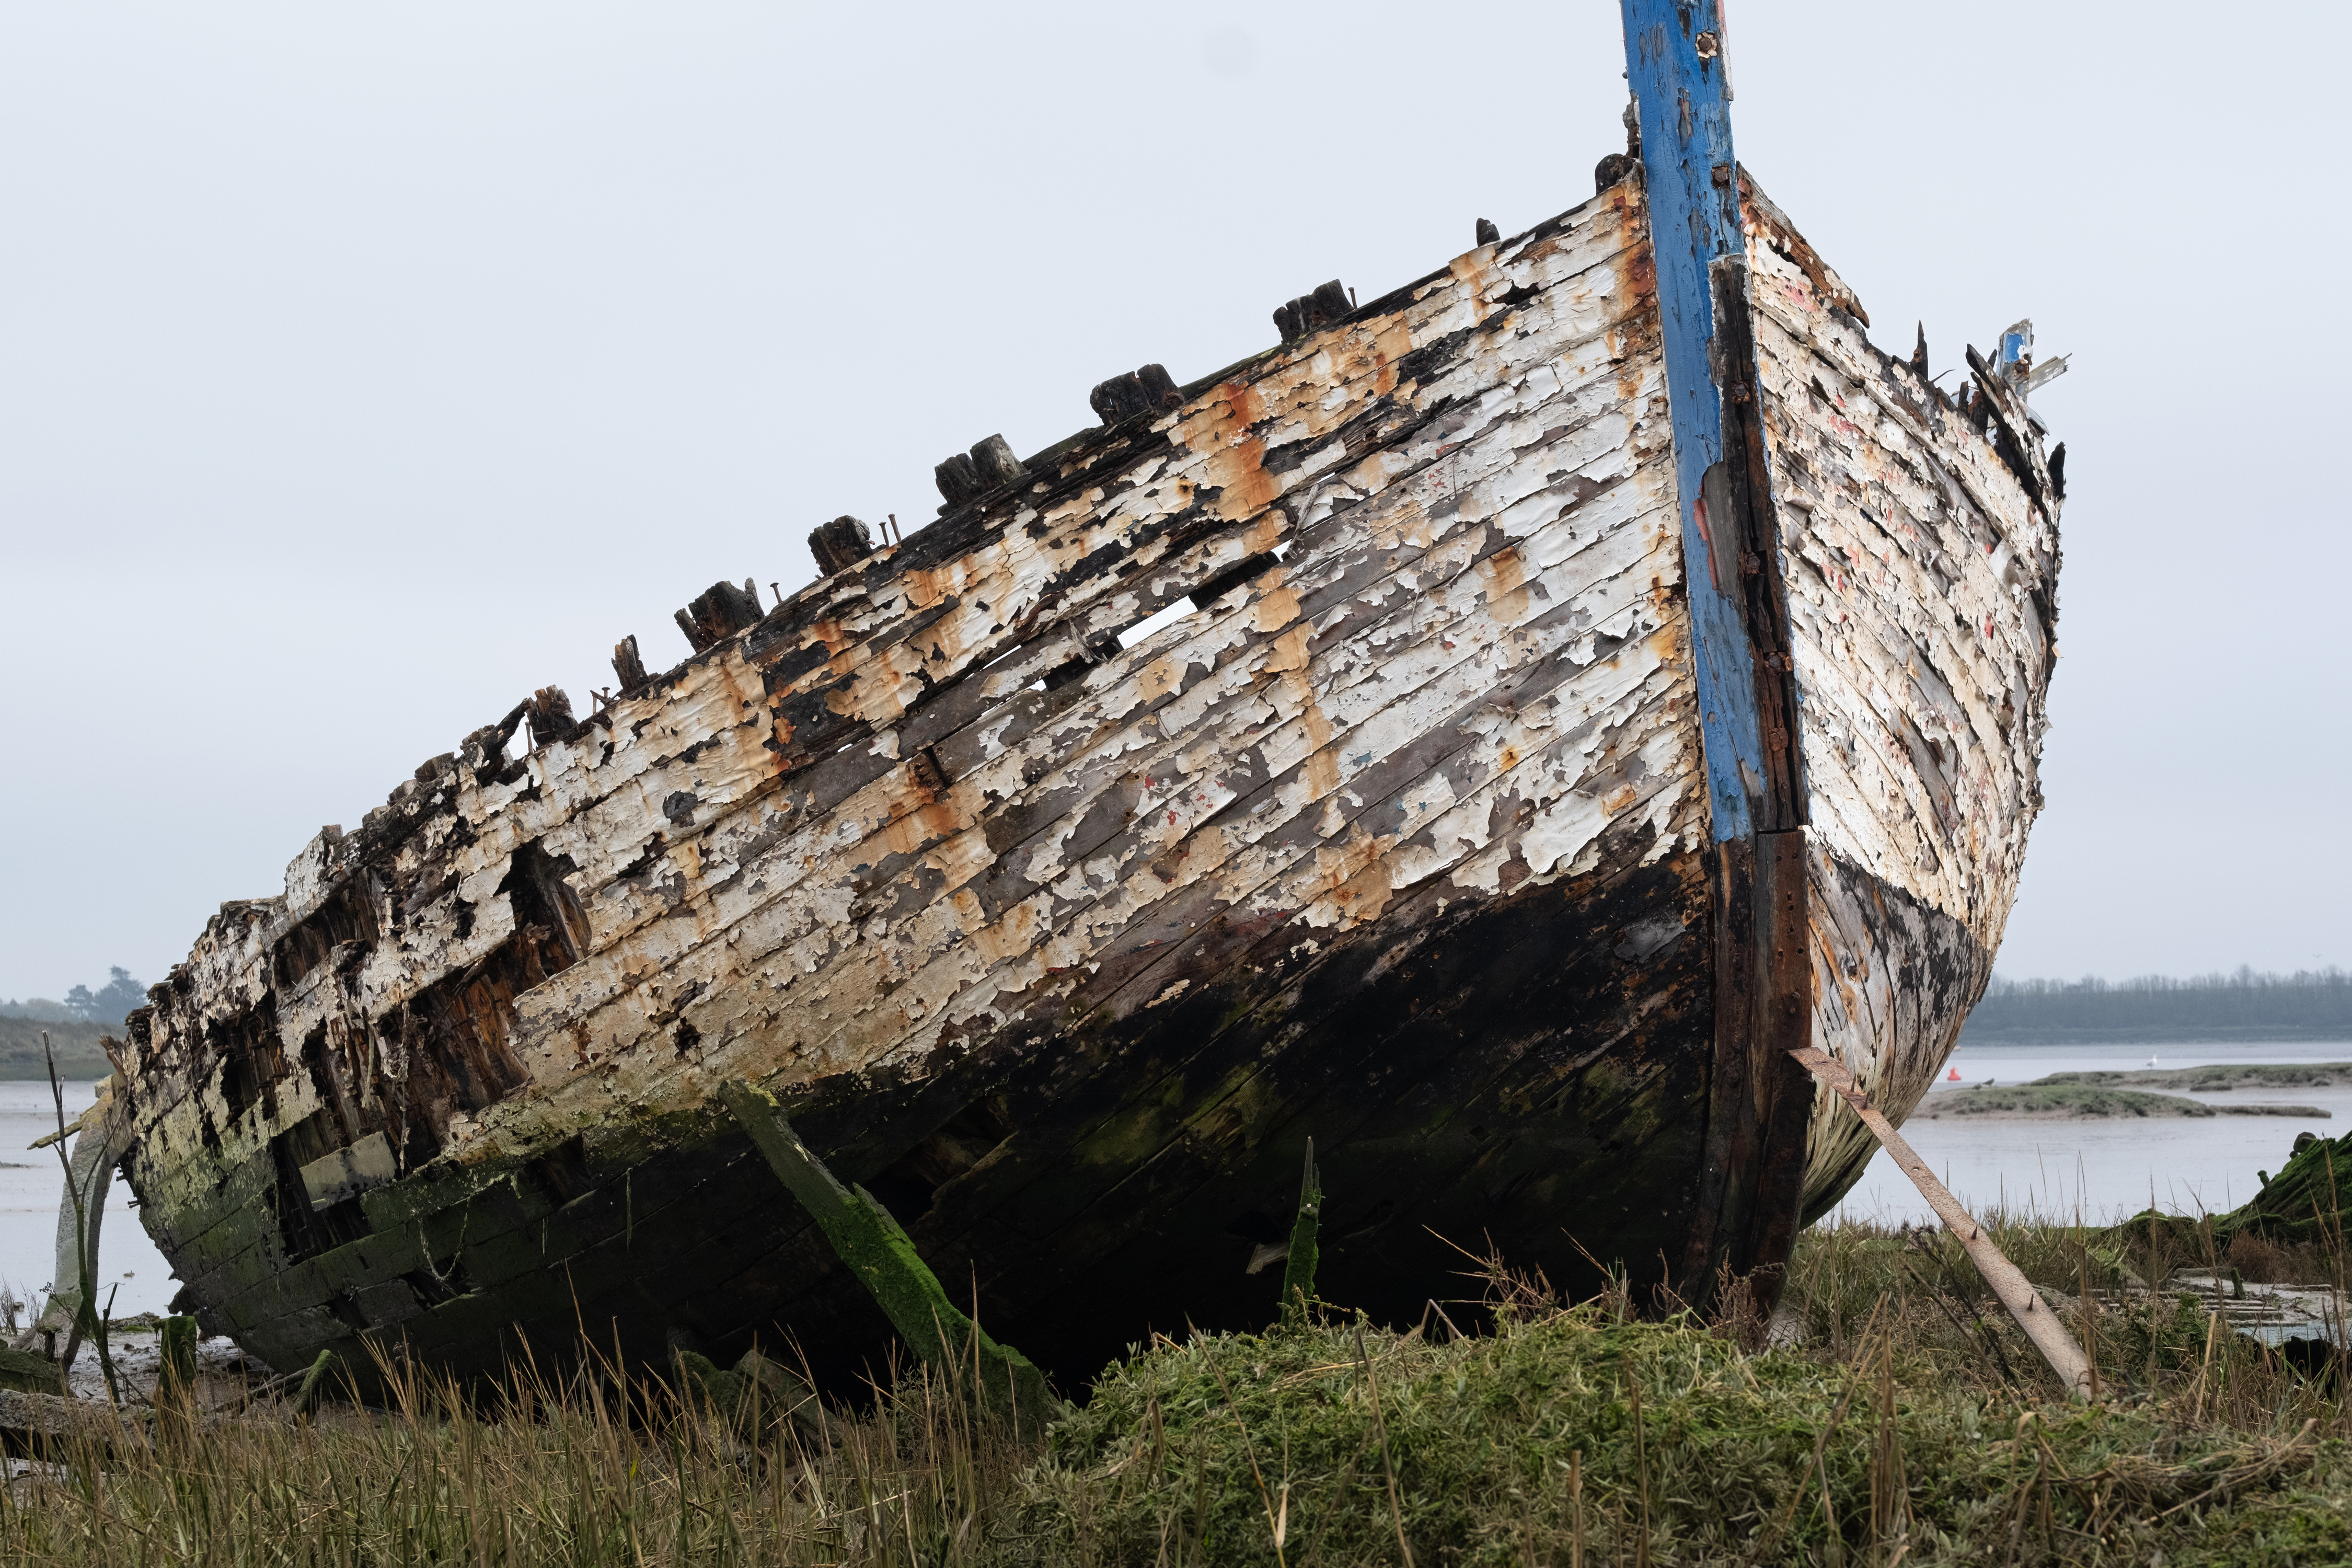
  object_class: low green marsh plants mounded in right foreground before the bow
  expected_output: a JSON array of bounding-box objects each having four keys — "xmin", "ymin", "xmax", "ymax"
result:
[{"xmin": 1000, "ymin": 1232, "xmax": 2352, "ymax": 1568}]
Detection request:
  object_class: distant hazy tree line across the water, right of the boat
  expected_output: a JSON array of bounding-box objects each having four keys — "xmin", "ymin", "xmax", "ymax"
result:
[{"xmin": 1962, "ymin": 966, "xmax": 2352, "ymax": 1044}]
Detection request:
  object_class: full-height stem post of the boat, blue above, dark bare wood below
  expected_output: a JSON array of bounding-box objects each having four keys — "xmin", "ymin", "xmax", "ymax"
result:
[{"xmin": 1621, "ymin": 0, "xmax": 1816, "ymax": 1312}]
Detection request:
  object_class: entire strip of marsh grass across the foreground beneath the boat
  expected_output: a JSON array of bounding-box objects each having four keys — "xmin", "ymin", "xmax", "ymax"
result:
[{"xmin": 14, "ymin": 1215, "xmax": 2352, "ymax": 1568}]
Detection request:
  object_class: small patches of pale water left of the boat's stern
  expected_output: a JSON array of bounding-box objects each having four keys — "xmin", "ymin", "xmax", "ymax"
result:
[{"xmin": 0, "ymin": 1081, "xmax": 179, "ymax": 1321}]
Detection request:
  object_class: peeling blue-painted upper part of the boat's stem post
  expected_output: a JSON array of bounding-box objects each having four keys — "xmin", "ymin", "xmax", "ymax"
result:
[{"xmin": 1623, "ymin": 0, "xmax": 1764, "ymax": 844}]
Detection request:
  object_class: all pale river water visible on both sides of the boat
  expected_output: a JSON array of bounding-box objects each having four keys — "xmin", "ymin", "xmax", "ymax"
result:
[{"xmin": 0, "ymin": 1042, "xmax": 2352, "ymax": 1317}]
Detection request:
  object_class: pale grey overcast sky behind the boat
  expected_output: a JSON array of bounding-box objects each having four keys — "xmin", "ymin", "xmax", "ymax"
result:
[{"xmin": 0, "ymin": 0, "xmax": 2352, "ymax": 997}]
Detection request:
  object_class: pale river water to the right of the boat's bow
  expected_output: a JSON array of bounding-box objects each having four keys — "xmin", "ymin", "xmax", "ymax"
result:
[{"xmin": 1832, "ymin": 1042, "xmax": 2352, "ymax": 1225}]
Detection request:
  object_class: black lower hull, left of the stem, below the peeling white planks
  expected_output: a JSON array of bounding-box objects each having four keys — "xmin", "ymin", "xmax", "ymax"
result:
[{"xmin": 183, "ymin": 830, "xmax": 1712, "ymax": 1387}]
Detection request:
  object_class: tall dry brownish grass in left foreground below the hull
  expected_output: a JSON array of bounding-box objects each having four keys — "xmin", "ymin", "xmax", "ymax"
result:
[{"xmin": 0, "ymin": 1335, "xmax": 1023, "ymax": 1568}]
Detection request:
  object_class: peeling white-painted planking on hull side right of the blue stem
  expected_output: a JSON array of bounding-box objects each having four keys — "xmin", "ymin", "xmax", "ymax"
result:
[{"xmin": 1757, "ymin": 213, "xmax": 2056, "ymax": 950}]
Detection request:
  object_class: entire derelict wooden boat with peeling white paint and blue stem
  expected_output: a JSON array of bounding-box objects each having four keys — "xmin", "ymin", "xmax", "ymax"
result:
[{"xmin": 118, "ymin": 12, "xmax": 2058, "ymax": 1385}]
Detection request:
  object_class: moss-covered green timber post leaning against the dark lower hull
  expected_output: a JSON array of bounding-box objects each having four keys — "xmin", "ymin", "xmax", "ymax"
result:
[{"xmin": 720, "ymin": 1083, "xmax": 1063, "ymax": 1432}]
